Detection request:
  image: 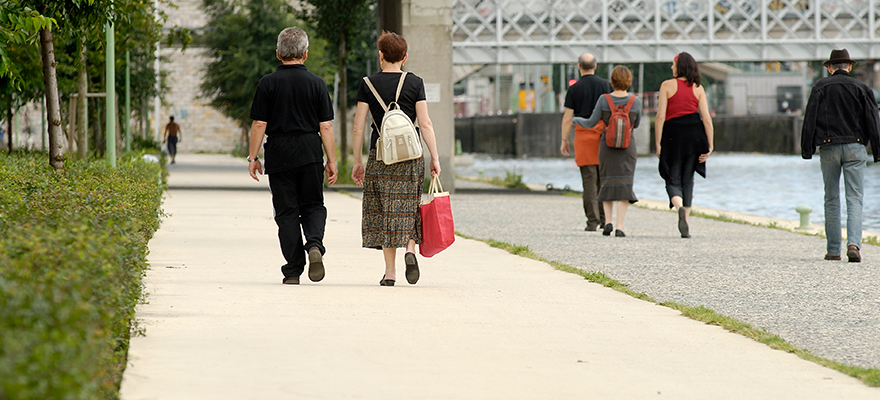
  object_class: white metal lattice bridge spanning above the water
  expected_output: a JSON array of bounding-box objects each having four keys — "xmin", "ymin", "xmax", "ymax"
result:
[{"xmin": 452, "ymin": 0, "xmax": 880, "ymax": 66}]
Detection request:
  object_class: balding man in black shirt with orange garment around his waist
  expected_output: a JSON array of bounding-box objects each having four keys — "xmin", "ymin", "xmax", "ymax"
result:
[{"xmin": 559, "ymin": 53, "xmax": 614, "ymax": 231}]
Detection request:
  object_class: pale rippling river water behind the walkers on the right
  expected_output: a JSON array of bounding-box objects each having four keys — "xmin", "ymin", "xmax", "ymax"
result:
[{"xmin": 455, "ymin": 153, "xmax": 880, "ymax": 231}]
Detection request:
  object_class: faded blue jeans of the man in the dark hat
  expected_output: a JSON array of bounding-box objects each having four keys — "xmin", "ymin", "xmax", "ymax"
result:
[{"xmin": 819, "ymin": 143, "xmax": 868, "ymax": 255}]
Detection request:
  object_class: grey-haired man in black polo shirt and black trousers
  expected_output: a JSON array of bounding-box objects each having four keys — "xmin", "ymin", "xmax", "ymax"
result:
[{"xmin": 248, "ymin": 28, "xmax": 337, "ymax": 285}]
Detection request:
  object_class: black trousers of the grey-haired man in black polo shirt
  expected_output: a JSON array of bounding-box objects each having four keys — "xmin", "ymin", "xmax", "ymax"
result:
[{"xmin": 269, "ymin": 163, "xmax": 327, "ymax": 276}]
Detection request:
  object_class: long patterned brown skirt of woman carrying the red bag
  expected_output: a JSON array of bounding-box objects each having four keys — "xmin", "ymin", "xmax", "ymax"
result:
[{"xmin": 361, "ymin": 149, "xmax": 425, "ymax": 249}]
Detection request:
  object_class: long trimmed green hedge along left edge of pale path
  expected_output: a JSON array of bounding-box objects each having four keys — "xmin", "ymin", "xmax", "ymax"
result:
[{"xmin": 0, "ymin": 154, "xmax": 164, "ymax": 400}]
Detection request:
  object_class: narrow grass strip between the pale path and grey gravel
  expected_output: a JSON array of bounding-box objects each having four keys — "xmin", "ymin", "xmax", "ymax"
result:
[{"xmin": 456, "ymin": 232, "xmax": 880, "ymax": 387}]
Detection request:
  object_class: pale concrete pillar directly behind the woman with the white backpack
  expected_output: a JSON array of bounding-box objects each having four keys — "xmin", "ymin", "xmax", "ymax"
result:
[{"xmin": 400, "ymin": 0, "xmax": 455, "ymax": 192}]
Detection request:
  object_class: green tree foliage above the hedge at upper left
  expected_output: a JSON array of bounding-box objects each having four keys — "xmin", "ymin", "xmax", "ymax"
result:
[{"xmin": 0, "ymin": 0, "xmax": 172, "ymax": 161}]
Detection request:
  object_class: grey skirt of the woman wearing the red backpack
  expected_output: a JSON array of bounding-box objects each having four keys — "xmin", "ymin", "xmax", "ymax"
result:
[{"xmin": 597, "ymin": 133, "xmax": 639, "ymax": 203}]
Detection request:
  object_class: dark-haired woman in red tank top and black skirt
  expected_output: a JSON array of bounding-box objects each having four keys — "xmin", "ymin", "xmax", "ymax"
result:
[{"xmin": 654, "ymin": 52, "xmax": 715, "ymax": 238}]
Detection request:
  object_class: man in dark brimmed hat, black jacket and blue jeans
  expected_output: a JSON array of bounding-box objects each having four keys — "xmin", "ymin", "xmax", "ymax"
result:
[{"xmin": 801, "ymin": 49, "xmax": 880, "ymax": 262}]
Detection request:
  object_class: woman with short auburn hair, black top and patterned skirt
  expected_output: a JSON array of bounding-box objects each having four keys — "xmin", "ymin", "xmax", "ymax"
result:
[{"xmin": 351, "ymin": 32, "xmax": 440, "ymax": 286}]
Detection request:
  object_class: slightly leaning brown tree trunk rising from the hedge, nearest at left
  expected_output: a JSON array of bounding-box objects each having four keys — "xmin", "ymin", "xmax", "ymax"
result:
[{"xmin": 40, "ymin": 29, "xmax": 65, "ymax": 171}]
